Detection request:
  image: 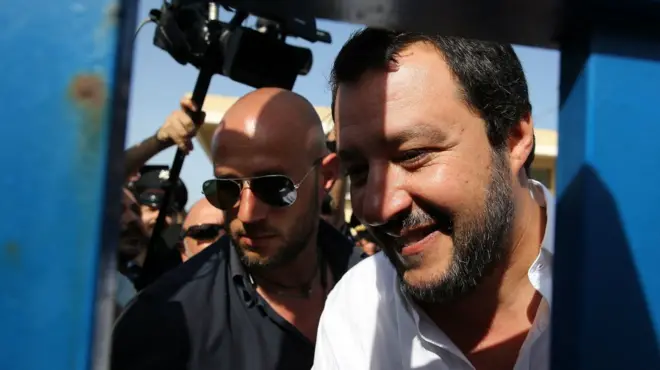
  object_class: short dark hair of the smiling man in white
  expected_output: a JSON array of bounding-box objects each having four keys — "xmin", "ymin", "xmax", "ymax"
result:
[{"xmin": 330, "ymin": 28, "xmax": 534, "ymax": 174}]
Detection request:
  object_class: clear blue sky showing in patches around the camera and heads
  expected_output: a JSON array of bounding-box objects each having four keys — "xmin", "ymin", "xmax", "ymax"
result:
[{"xmin": 126, "ymin": 0, "xmax": 559, "ymax": 207}]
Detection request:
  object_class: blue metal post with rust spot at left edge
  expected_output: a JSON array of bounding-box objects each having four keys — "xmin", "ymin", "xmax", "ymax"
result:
[{"xmin": 0, "ymin": 0, "xmax": 137, "ymax": 370}]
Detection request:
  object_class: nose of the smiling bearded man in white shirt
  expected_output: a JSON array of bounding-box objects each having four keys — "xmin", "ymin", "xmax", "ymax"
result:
[{"xmin": 356, "ymin": 165, "xmax": 412, "ymax": 226}]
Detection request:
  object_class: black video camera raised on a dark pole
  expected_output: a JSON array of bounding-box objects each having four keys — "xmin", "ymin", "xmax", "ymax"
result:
[{"xmin": 141, "ymin": 0, "xmax": 332, "ymax": 289}]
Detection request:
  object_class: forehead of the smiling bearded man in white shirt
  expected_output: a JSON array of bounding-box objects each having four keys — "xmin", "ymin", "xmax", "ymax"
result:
[{"xmin": 335, "ymin": 45, "xmax": 463, "ymax": 155}]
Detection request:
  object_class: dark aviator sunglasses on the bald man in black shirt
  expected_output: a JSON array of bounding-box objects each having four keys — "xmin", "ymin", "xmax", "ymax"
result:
[{"xmin": 202, "ymin": 158, "xmax": 323, "ymax": 211}]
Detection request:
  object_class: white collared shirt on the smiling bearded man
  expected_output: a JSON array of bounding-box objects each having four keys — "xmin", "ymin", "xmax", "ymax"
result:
[{"xmin": 313, "ymin": 180, "xmax": 555, "ymax": 370}]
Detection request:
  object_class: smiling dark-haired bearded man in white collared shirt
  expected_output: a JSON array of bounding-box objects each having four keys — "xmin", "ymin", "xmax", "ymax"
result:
[{"xmin": 314, "ymin": 28, "xmax": 554, "ymax": 370}]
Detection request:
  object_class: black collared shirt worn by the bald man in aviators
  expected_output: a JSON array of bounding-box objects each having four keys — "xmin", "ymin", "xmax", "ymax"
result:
[{"xmin": 111, "ymin": 221, "xmax": 360, "ymax": 370}]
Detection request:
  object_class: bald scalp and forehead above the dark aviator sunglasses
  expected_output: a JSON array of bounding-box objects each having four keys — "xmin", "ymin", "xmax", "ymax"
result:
[{"xmin": 212, "ymin": 88, "xmax": 327, "ymax": 164}]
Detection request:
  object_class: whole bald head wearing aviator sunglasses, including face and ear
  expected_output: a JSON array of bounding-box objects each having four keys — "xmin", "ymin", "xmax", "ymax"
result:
[{"xmin": 205, "ymin": 88, "xmax": 339, "ymax": 267}]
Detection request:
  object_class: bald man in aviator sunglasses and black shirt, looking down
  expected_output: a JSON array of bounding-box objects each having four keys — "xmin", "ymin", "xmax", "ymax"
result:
[{"xmin": 112, "ymin": 88, "xmax": 361, "ymax": 370}]
